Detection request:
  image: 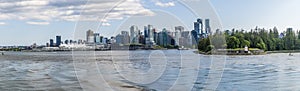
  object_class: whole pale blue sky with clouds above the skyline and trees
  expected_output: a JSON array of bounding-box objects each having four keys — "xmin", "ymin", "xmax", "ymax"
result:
[{"xmin": 0, "ymin": 0, "xmax": 300, "ymax": 46}]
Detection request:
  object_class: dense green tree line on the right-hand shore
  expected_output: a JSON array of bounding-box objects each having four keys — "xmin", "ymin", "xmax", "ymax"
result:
[{"xmin": 198, "ymin": 27, "xmax": 300, "ymax": 52}]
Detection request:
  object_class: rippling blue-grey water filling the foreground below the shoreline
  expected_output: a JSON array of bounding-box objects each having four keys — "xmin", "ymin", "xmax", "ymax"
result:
[{"xmin": 0, "ymin": 50, "xmax": 300, "ymax": 91}]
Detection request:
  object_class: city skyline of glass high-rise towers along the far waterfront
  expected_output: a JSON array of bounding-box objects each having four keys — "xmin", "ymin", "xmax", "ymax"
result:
[{"xmin": 40, "ymin": 18, "xmax": 212, "ymax": 48}]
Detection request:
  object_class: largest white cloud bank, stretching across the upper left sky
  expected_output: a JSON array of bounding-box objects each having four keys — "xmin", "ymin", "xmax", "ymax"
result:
[{"xmin": 0, "ymin": 0, "xmax": 154, "ymax": 25}]
